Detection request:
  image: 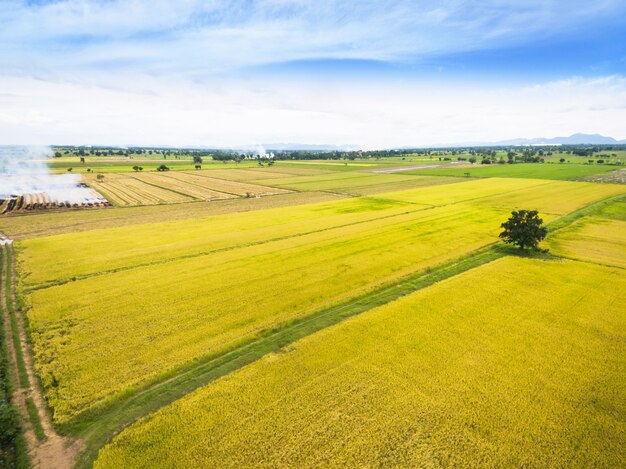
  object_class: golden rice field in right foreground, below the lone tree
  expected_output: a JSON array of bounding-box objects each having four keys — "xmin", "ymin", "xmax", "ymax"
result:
[{"xmin": 95, "ymin": 258, "xmax": 626, "ymax": 469}]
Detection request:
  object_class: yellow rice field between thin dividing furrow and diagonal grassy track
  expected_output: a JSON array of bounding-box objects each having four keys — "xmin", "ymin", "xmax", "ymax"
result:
[{"xmin": 27, "ymin": 202, "xmax": 506, "ymax": 423}]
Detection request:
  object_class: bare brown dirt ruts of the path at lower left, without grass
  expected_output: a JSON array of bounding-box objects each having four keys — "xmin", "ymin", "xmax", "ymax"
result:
[{"xmin": 0, "ymin": 235, "xmax": 83, "ymax": 469}]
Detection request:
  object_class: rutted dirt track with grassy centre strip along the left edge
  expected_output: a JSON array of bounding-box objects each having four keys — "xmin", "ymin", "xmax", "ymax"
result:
[{"xmin": 1, "ymin": 243, "xmax": 83, "ymax": 469}]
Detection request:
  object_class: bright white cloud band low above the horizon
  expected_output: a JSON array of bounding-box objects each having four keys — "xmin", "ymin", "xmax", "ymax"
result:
[{"xmin": 0, "ymin": 76, "xmax": 626, "ymax": 148}]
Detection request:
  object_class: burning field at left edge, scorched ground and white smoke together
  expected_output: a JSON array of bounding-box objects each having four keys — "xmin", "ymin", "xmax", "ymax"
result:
[{"xmin": 0, "ymin": 147, "xmax": 110, "ymax": 214}]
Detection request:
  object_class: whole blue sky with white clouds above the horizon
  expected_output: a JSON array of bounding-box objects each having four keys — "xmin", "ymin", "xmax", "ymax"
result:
[{"xmin": 0, "ymin": 0, "xmax": 626, "ymax": 149}]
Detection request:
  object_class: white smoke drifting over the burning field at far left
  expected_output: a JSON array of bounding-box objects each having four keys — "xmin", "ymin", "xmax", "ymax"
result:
[{"xmin": 0, "ymin": 146, "xmax": 102, "ymax": 204}]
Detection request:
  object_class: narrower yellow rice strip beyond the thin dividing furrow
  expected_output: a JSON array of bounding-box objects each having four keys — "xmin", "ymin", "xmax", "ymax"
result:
[{"xmin": 20, "ymin": 194, "xmax": 420, "ymax": 287}]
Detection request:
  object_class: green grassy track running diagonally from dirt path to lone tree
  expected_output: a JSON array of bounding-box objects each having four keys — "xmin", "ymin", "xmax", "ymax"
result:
[{"xmin": 68, "ymin": 243, "xmax": 509, "ymax": 467}]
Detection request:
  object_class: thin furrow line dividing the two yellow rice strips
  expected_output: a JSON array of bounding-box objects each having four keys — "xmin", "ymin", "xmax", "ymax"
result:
[{"xmin": 23, "ymin": 205, "xmax": 437, "ymax": 293}]
